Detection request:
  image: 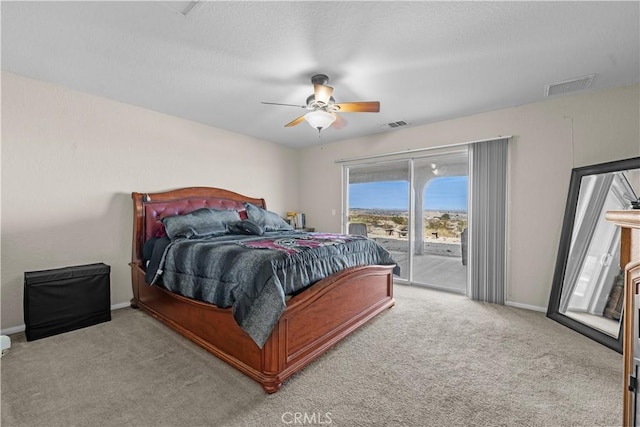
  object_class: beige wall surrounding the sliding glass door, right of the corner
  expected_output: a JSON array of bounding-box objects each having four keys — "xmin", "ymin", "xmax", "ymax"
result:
[{"xmin": 299, "ymin": 85, "xmax": 640, "ymax": 309}]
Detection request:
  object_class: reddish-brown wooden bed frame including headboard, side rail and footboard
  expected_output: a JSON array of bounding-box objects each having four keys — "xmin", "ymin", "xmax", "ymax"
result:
[{"xmin": 129, "ymin": 187, "xmax": 394, "ymax": 393}]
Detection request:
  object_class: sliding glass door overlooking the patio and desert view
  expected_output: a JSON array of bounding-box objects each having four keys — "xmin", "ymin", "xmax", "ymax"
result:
[{"xmin": 345, "ymin": 149, "xmax": 468, "ymax": 293}]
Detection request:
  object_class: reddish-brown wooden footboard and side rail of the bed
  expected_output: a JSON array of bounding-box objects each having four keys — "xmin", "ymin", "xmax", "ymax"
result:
[{"xmin": 131, "ymin": 263, "xmax": 394, "ymax": 393}]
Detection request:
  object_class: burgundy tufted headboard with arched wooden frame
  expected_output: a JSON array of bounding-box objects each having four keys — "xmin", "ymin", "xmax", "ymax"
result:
[{"xmin": 131, "ymin": 187, "xmax": 267, "ymax": 265}]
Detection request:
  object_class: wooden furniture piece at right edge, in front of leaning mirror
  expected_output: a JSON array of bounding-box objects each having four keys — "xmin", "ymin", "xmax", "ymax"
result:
[{"xmin": 605, "ymin": 209, "xmax": 640, "ymax": 426}]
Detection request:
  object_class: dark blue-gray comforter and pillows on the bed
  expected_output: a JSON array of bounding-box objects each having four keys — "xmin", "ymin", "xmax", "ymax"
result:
[{"xmin": 144, "ymin": 203, "xmax": 399, "ymax": 348}]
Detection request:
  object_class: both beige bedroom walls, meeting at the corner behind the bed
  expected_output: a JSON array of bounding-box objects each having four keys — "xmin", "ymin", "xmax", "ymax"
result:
[{"xmin": 0, "ymin": 73, "xmax": 640, "ymax": 330}]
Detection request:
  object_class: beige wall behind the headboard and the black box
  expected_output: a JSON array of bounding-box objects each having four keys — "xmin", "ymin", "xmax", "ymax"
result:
[{"xmin": 1, "ymin": 73, "xmax": 298, "ymax": 330}]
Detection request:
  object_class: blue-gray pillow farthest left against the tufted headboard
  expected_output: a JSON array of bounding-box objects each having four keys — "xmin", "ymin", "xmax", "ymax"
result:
[{"xmin": 162, "ymin": 208, "xmax": 240, "ymax": 240}]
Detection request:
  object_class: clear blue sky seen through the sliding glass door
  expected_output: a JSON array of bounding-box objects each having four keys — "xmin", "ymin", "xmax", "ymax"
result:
[{"xmin": 349, "ymin": 176, "xmax": 467, "ymax": 212}]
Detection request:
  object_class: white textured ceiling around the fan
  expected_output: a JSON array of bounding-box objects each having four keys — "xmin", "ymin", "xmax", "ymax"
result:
[{"xmin": 1, "ymin": 1, "xmax": 640, "ymax": 147}]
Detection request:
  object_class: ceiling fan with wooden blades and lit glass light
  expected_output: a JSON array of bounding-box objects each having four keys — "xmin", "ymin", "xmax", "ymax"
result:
[{"xmin": 263, "ymin": 74, "xmax": 380, "ymax": 132}]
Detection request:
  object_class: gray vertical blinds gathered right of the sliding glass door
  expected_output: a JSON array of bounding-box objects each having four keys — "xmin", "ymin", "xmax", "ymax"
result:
[{"xmin": 467, "ymin": 138, "xmax": 508, "ymax": 304}]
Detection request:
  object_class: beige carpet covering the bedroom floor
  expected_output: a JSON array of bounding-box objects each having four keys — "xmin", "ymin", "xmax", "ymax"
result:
[{"xmin": 0, "ymin": 285, "xmax": 622, "ymax": 427}]
